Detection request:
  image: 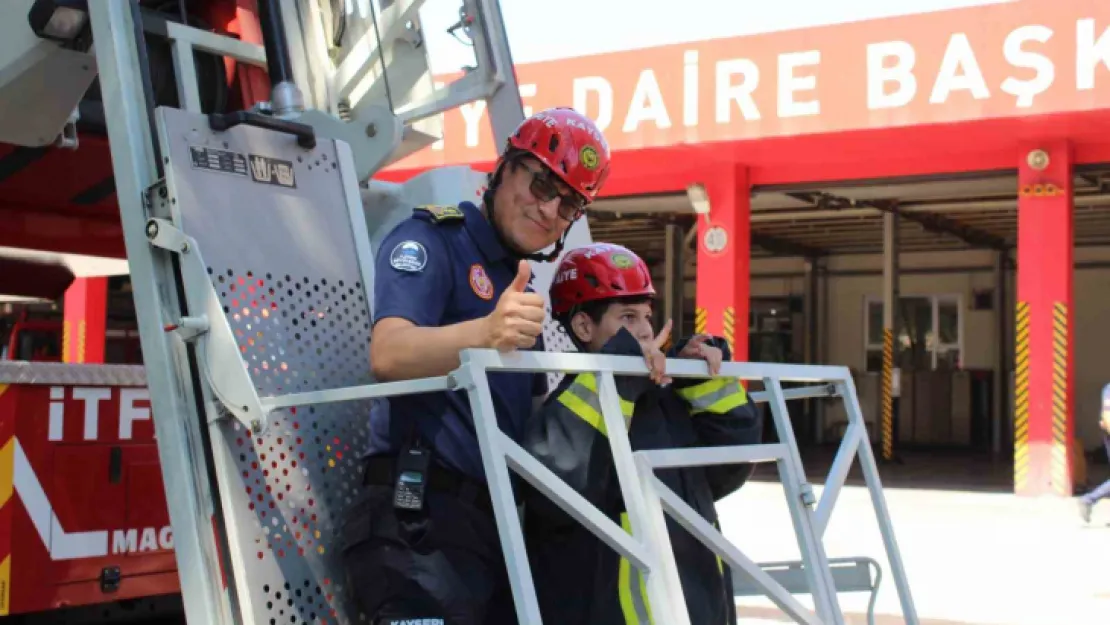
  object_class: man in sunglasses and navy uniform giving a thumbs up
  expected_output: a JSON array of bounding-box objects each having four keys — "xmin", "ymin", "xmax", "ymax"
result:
[{"xmin": 343, "ymin": 108, "xmax": 609, "ymax": 625}]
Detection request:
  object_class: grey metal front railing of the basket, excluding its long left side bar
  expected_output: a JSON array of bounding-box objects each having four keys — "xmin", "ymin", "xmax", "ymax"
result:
[{"xmin": 450, "ymin": 350, "xmax": 917, "ymax": 624}]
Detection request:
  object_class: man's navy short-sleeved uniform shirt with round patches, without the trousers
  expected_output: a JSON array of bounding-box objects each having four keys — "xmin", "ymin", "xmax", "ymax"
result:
[{"xmin": 371, "ymin": 202, "xmax": 546, "ymax": 482}]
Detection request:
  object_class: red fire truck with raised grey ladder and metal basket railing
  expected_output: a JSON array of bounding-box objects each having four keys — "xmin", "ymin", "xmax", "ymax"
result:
[{"xmin": 0, "ymin": 0, "xmax": 917, "ymax": 625}]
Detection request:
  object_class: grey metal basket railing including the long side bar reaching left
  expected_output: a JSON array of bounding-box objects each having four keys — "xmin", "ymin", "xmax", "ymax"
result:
[{"xmin": 240, "ymin": 350, "xmax": 918, "ymax": 625}]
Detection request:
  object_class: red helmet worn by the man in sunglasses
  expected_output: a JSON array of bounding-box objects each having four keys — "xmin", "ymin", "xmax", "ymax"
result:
[{"xmin": 508, "ymin": 107, "xmax": 609, "ymax": 202}]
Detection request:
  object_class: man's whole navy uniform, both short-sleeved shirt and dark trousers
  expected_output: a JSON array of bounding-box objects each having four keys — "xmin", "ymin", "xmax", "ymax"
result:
[{"xmin": 343, "ymin": 202, "xmax": 546, "ymax": 625}]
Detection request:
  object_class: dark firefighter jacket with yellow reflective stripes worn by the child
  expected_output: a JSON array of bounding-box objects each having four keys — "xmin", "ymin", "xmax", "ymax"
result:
[{"xmin": 523, "ymin": 330, "xmax": 763, "ymax": 625}]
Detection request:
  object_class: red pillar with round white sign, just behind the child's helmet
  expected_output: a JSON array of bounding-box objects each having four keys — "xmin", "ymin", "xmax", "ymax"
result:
[{"xmin": 694, "ymin": 164, "xmax": 751, "ymax": 361}]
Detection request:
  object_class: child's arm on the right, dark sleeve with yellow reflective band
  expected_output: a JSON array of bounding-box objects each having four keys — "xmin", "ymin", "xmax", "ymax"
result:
[{"xmin": 668, "ymin": 336, "xmax": 764, "ymax": 498}]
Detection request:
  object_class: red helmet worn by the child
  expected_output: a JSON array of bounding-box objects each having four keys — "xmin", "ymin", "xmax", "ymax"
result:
[{"xmin": 551, "ymin": 243, "xmax": 655, "ymax": 316}]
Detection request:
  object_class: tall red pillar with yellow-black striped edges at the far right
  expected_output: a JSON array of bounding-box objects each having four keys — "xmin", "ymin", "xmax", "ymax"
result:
[{"xmin": 1013, "ymin": 141, "xmax": 1074, "ymax": 496}]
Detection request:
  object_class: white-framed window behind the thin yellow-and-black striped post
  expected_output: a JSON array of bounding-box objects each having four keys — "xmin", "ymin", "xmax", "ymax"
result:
[{"xmin": 864, "ymin": 295, "xmax": 962, "ymax": 371}]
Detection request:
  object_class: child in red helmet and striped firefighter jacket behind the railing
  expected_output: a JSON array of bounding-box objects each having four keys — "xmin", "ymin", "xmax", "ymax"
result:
[{"xmin": 523, "ymin": 243, "xmax": 763, "ymax": 625}]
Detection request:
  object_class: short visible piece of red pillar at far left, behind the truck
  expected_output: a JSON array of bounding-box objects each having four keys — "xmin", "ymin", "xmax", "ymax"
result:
[{"xmin": 62, "ymin": 278, "xmax": 108, "ymax": 364}]
